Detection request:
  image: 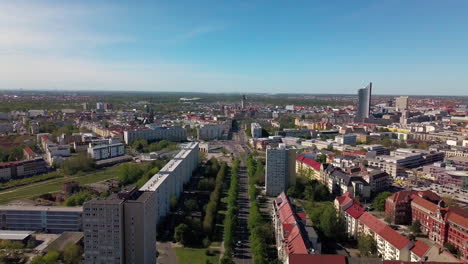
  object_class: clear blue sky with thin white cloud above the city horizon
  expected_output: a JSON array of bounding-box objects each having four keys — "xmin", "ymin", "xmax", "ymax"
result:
[{"xmin": 0, "ymin": 0, "xmax": 468, "ymax": 95}]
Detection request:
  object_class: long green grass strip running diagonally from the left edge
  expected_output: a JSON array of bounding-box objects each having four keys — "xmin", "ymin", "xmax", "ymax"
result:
[{"xmin": 0, "ymin": 165, "xmax": 124, "ymax": 204}]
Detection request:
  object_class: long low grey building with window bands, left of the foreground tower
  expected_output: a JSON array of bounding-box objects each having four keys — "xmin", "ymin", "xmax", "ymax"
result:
[{"xmin": 0, "ymin": 205, "xmax": 83, "ymax": 233}]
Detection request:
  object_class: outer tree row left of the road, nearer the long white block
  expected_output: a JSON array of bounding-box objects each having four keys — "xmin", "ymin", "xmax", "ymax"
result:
[{"xmin": 203, "ymin": 162, "xmax": 227, "ymax": 237}]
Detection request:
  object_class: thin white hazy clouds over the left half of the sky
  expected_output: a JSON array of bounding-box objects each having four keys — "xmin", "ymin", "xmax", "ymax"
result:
[{"xmin": 0, "ymin": 0, "xmax": 238, "ymax": 90}]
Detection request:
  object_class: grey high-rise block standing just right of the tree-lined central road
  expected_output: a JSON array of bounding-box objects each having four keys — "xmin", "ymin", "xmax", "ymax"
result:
[{"xmin": 265, "ymin": 144, "xmax": 296, "ymax": 196}]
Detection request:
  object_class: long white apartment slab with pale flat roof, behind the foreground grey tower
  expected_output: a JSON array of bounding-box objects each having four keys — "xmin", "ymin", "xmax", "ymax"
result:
[{"xmin": 140, "ymin": 142, "xmax": 198, "ymax": 223}]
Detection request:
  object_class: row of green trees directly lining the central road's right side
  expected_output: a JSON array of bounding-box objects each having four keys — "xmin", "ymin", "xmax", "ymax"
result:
[{"xmin": 247, "ymin": 154, "xmax": 271, "ymax": 264}]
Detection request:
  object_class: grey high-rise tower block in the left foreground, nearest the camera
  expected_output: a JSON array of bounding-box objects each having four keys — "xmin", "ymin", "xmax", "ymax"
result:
[{"xmin": 83, "ymin": 187, "xmax": 156, "ymax": 264}]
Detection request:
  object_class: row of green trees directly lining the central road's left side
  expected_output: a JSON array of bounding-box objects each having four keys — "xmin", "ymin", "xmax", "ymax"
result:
[{"xmin": 221, "ymin": 159, "xmax": 240, "ymax": 263}]
